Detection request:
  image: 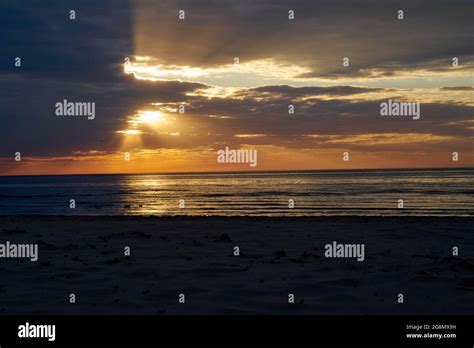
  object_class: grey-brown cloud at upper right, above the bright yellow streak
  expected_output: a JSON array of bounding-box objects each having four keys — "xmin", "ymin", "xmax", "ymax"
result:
[{"xmin": 135, "ymin": 0, "xmax": 474, "ymax": 78}]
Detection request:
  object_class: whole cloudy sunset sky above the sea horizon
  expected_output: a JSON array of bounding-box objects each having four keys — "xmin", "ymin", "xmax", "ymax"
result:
[{"xmin": 0, "ymin": 0, "xmax": 474, "ymax": 175}]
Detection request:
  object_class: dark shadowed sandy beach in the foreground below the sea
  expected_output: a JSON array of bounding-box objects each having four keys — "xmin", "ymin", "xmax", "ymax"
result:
[{"xmin": 0, "ymin": 216, "xmax": 474, "ymax": 315}]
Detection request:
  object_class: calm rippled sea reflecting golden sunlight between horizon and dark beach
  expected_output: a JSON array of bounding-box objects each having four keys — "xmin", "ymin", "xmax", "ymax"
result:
[{"xmin": 0, "ymin": 170, "xmax": 474, "ymax": 216}]
